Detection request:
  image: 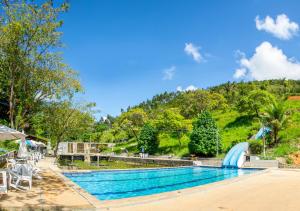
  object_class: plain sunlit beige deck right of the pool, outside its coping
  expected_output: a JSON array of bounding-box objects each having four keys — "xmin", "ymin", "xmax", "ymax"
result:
[{"xmin": 105, "ymin": 169, "xmax": 300, "ymax": 211}]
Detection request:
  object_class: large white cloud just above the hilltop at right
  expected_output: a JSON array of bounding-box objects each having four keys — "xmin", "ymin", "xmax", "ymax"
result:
[{"xmin": 234, "ymin": 42, "xmax": 300, "ymax": 80}]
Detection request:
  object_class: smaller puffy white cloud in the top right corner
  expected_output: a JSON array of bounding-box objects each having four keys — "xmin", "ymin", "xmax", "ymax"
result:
[{"xmin": 255, "ymin": 14, "xmax": 299, "ymax": 40}]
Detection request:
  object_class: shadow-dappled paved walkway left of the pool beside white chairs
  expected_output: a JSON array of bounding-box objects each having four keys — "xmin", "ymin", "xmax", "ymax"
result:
[{"xmin": 0, "ymin": 158, "xmax": 93, "ymax": 210}]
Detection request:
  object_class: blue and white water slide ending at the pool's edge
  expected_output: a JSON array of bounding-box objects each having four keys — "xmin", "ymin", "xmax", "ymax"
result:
[{"xmin": 222, "ymin": 142, "xmax": 249, "ymax": 168}]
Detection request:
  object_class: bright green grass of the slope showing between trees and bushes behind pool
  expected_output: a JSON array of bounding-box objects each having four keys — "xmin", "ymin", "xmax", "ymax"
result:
[{"xmin": 110, "ymin": 101, "xmax": 300, "ymax": 160}]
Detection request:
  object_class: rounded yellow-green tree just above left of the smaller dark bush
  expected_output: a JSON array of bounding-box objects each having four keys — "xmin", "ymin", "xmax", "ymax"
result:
[{"xmin": 117, "ymin": 108, "xmax": 148, "ymax": 139}]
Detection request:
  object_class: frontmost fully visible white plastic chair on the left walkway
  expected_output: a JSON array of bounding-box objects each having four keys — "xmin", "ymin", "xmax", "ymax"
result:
[{"xmin": 9, "ymin": 164, "xmax": 32, "ymax": 190}]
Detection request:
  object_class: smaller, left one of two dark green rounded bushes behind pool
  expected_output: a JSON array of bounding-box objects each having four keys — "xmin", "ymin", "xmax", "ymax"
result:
[{"xmin": 137, "ymin": 124, "xmax": 159, "ymax": 154}]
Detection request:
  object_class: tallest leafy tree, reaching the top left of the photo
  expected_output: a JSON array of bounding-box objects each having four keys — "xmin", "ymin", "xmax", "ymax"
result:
[{"xmin": 0, "ymin": 0, "xmax": 81, "ymax": 129}]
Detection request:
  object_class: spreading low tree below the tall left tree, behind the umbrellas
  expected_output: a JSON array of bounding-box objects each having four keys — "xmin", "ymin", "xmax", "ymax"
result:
[{"xmin": 43, "ymin": 101, "xmax": 94, "ymax": 155}]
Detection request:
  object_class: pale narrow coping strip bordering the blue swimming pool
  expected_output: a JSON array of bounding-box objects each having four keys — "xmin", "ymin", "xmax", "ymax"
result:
[{"xmin": 51, "ymin": 162, "xmax": 272, "ymax": 209}]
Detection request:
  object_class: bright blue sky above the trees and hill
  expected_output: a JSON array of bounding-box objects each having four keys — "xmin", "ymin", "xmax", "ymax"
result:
[{"xmin": 62, "ymin": 0, "xmax": 300, "ymax": 115}]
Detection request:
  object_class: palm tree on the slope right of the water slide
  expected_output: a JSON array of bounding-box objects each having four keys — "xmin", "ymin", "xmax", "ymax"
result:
[{"xmin": 261, "ymin": 102, "xmax": 289, "ymax": 143}]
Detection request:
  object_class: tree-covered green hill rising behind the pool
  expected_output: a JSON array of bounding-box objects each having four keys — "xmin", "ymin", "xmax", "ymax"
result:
[{"xmin": 101, "ymin": 80, "xmax": 300, "ymax": 163}]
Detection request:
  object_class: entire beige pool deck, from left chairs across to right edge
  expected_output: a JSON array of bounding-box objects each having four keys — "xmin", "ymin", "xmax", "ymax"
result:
[{"xmin": 0, "ymin": 158, "xmax": 300, "ymax": 211}]
